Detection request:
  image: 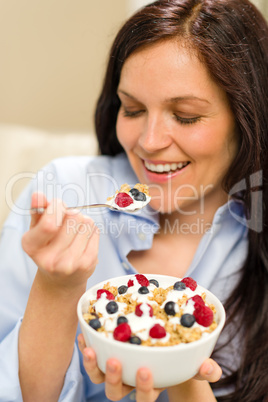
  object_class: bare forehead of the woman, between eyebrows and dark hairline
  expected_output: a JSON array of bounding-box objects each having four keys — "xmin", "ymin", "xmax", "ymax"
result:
[{"xmin": 119, "ymin": 39, "xmax": 225, "ymax": 104}]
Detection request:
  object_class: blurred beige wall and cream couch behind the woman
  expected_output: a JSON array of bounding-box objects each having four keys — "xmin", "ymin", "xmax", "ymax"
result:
[{"xmin": 0, "ymin": 0, "xmax": 268, "ymax": 226}]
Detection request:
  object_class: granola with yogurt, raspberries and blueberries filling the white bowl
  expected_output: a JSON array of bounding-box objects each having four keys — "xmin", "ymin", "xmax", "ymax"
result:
[{"xmin": 83, "ymin": 274, "xmax": 217, "ymax": 346}]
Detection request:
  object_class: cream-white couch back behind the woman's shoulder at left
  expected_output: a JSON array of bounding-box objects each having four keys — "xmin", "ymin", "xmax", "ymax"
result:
[{"xmin": 0, "ymin": 124, "xmax": 98, "ymax": 227}]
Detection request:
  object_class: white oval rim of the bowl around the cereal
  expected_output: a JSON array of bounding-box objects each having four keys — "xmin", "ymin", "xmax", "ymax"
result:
[{"xmin": 77, "ymin": 274, "xmax": 226, "ymax": 353}]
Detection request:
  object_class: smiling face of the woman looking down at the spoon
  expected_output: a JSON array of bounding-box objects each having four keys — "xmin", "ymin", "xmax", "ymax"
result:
[{"xmin": 116, "ymin": 40, "xmax": 237, "ymax": 214}]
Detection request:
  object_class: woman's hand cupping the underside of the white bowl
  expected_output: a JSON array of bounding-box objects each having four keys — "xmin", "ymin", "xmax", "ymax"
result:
[{"xmin": 78, "ymin": 334, "xmax": 222, "ymax": 402}]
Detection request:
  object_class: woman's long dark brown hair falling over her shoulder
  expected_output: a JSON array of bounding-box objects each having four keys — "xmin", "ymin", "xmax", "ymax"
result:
[{"xmin": 95, "ymin": 0, "xmax": 268, "ymax": 402}]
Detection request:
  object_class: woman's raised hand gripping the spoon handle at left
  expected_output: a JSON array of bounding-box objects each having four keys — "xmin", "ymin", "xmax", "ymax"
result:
[{"xmin": 22, "ymin": 193, "xmax": 99, "ymax": 289}]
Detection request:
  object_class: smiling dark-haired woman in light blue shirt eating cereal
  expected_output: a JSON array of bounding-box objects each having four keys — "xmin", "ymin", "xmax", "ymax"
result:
[{"xmin": 0, "ymin": 0, "xmax": 268, "ymax": 402}]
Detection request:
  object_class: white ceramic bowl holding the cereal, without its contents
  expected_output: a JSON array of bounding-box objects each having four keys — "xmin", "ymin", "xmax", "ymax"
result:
[{"xmin": 77, "ymin": 274, "xmax": 225, "ymax": 388}]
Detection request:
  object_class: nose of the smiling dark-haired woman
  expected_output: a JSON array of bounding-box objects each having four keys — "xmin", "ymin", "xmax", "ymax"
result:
[{"xmin": 139, "ymin": 113, "xmax": 172, "ymax": 153}]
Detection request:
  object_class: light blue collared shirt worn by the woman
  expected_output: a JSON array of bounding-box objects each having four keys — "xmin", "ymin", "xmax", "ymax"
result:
[{"xmin": 0, "ymin": 155, "xmax": 248, "ymax": 402}]
